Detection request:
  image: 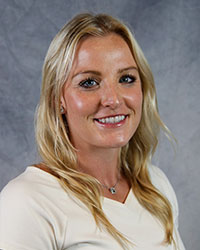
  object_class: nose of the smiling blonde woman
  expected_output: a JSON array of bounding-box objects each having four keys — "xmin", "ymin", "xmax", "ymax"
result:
[{"xmin": 101, "ymin": 83, "xmax": 122, "ymax": 109}]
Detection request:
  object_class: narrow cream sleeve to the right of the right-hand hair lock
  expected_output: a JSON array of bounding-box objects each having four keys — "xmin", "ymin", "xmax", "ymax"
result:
[{"xmin": 149, "ymin": 165, "xmax": 185, "ymax": 250}]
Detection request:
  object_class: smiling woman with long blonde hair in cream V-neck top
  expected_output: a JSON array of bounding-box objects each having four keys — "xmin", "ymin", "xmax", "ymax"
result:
[{"xmin": 0, "ymin": 14, "xmax": 184, "ymax": 250}]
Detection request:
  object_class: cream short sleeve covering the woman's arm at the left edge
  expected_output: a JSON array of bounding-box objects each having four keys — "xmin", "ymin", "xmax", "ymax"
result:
[{"xmin": 0, "ymin": 179, "xmax": 64, "ymax": 250}]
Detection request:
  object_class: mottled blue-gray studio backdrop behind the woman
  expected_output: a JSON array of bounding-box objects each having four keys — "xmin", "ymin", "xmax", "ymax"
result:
[{"xmin": 0, "ymin": 0, "xmax": 200, "ymax": 250}]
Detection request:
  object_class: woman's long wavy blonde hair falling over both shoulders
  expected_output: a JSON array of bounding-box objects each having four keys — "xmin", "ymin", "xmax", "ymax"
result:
[{"xmin": 36, "ymin": 13, "xmax": 173, "ymax": 247}]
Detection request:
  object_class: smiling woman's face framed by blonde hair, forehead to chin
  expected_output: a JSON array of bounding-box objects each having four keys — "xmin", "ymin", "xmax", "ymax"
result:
[{"xmin": 61, "ymin": 34, "xmax": 142, "ymax": 149}]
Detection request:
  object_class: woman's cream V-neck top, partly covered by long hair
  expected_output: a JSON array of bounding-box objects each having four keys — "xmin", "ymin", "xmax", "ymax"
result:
[{"xmin": 0, "ymin": 166, "xmax": 185, "ymax": 250}]
